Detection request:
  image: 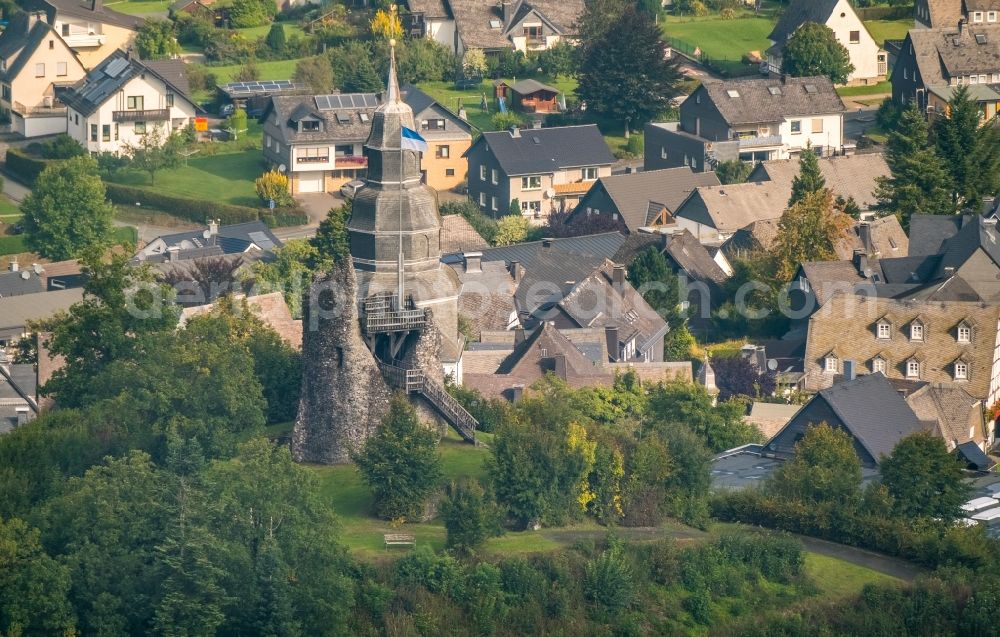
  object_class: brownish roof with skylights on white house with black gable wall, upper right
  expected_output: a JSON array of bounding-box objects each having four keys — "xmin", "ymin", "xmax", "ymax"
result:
[{"xmin": 696, "ymin": 77, "xmax": 844, "ymax": 126}]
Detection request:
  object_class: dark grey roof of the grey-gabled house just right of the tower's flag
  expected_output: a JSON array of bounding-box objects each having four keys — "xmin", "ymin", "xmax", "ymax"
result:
[{"xmin": 466, "ymin": 124, "xmax": 615, "ymax": 177}]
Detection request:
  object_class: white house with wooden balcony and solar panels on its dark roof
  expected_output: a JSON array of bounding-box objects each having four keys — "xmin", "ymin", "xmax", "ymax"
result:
[{"xmin": 58, "ymin": 51, "xmax": 198, "ymax": 153}]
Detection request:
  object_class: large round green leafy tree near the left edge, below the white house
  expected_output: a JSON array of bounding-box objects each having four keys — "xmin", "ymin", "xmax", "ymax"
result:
[{"xmin": 21, "ymin": 156, "xmax": 114, "ymax": 261}]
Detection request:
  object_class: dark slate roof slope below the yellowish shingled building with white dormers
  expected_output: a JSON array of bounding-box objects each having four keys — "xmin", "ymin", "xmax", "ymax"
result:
[{"xmin": 820, "ymin": 373, "xmax": 926, "ymax": 462}]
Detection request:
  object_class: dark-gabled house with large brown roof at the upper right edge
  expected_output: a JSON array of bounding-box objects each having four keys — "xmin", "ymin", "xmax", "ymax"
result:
[{"xmin": 892, "ymin": 18, "xmax": 1000, "ymax": 118}]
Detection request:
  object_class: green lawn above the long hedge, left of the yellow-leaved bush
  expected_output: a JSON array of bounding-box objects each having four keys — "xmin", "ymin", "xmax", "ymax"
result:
[{"xmin": 112, "ymin": 150, "xmax": 264, "ymax": 206}]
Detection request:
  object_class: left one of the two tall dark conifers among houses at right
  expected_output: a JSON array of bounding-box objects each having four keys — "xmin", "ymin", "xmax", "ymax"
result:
[{"xmin": 875, "ymin": 103, "xmax": 955, "ymax": 228}]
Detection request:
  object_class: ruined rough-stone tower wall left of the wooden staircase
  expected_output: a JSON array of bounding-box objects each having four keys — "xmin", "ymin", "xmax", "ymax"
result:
[{"xmin": 292, "ymin": 259, "xmax": 391, "ymax": 464}]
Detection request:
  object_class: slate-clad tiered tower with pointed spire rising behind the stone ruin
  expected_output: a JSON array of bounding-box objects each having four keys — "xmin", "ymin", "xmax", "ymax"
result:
[{"xmin": 347, "ymin": 41, "xmax": 459, "ymax": 344}]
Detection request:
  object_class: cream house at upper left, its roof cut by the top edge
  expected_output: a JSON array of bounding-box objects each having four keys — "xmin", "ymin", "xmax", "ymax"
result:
[{"xmin": 22, "ymin": 0, "xmax": 146, "ymax": 69}]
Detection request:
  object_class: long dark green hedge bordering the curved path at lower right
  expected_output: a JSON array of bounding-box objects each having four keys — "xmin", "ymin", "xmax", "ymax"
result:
[{"xmin": 711, "ymin": 489, "xmax": 1000, "ymax": 569}]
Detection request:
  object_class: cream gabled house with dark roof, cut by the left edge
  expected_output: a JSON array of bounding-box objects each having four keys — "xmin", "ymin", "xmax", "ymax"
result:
[{"xmin": 0, "ymin": 13, "xmax": 86, "ymax": 137}]
